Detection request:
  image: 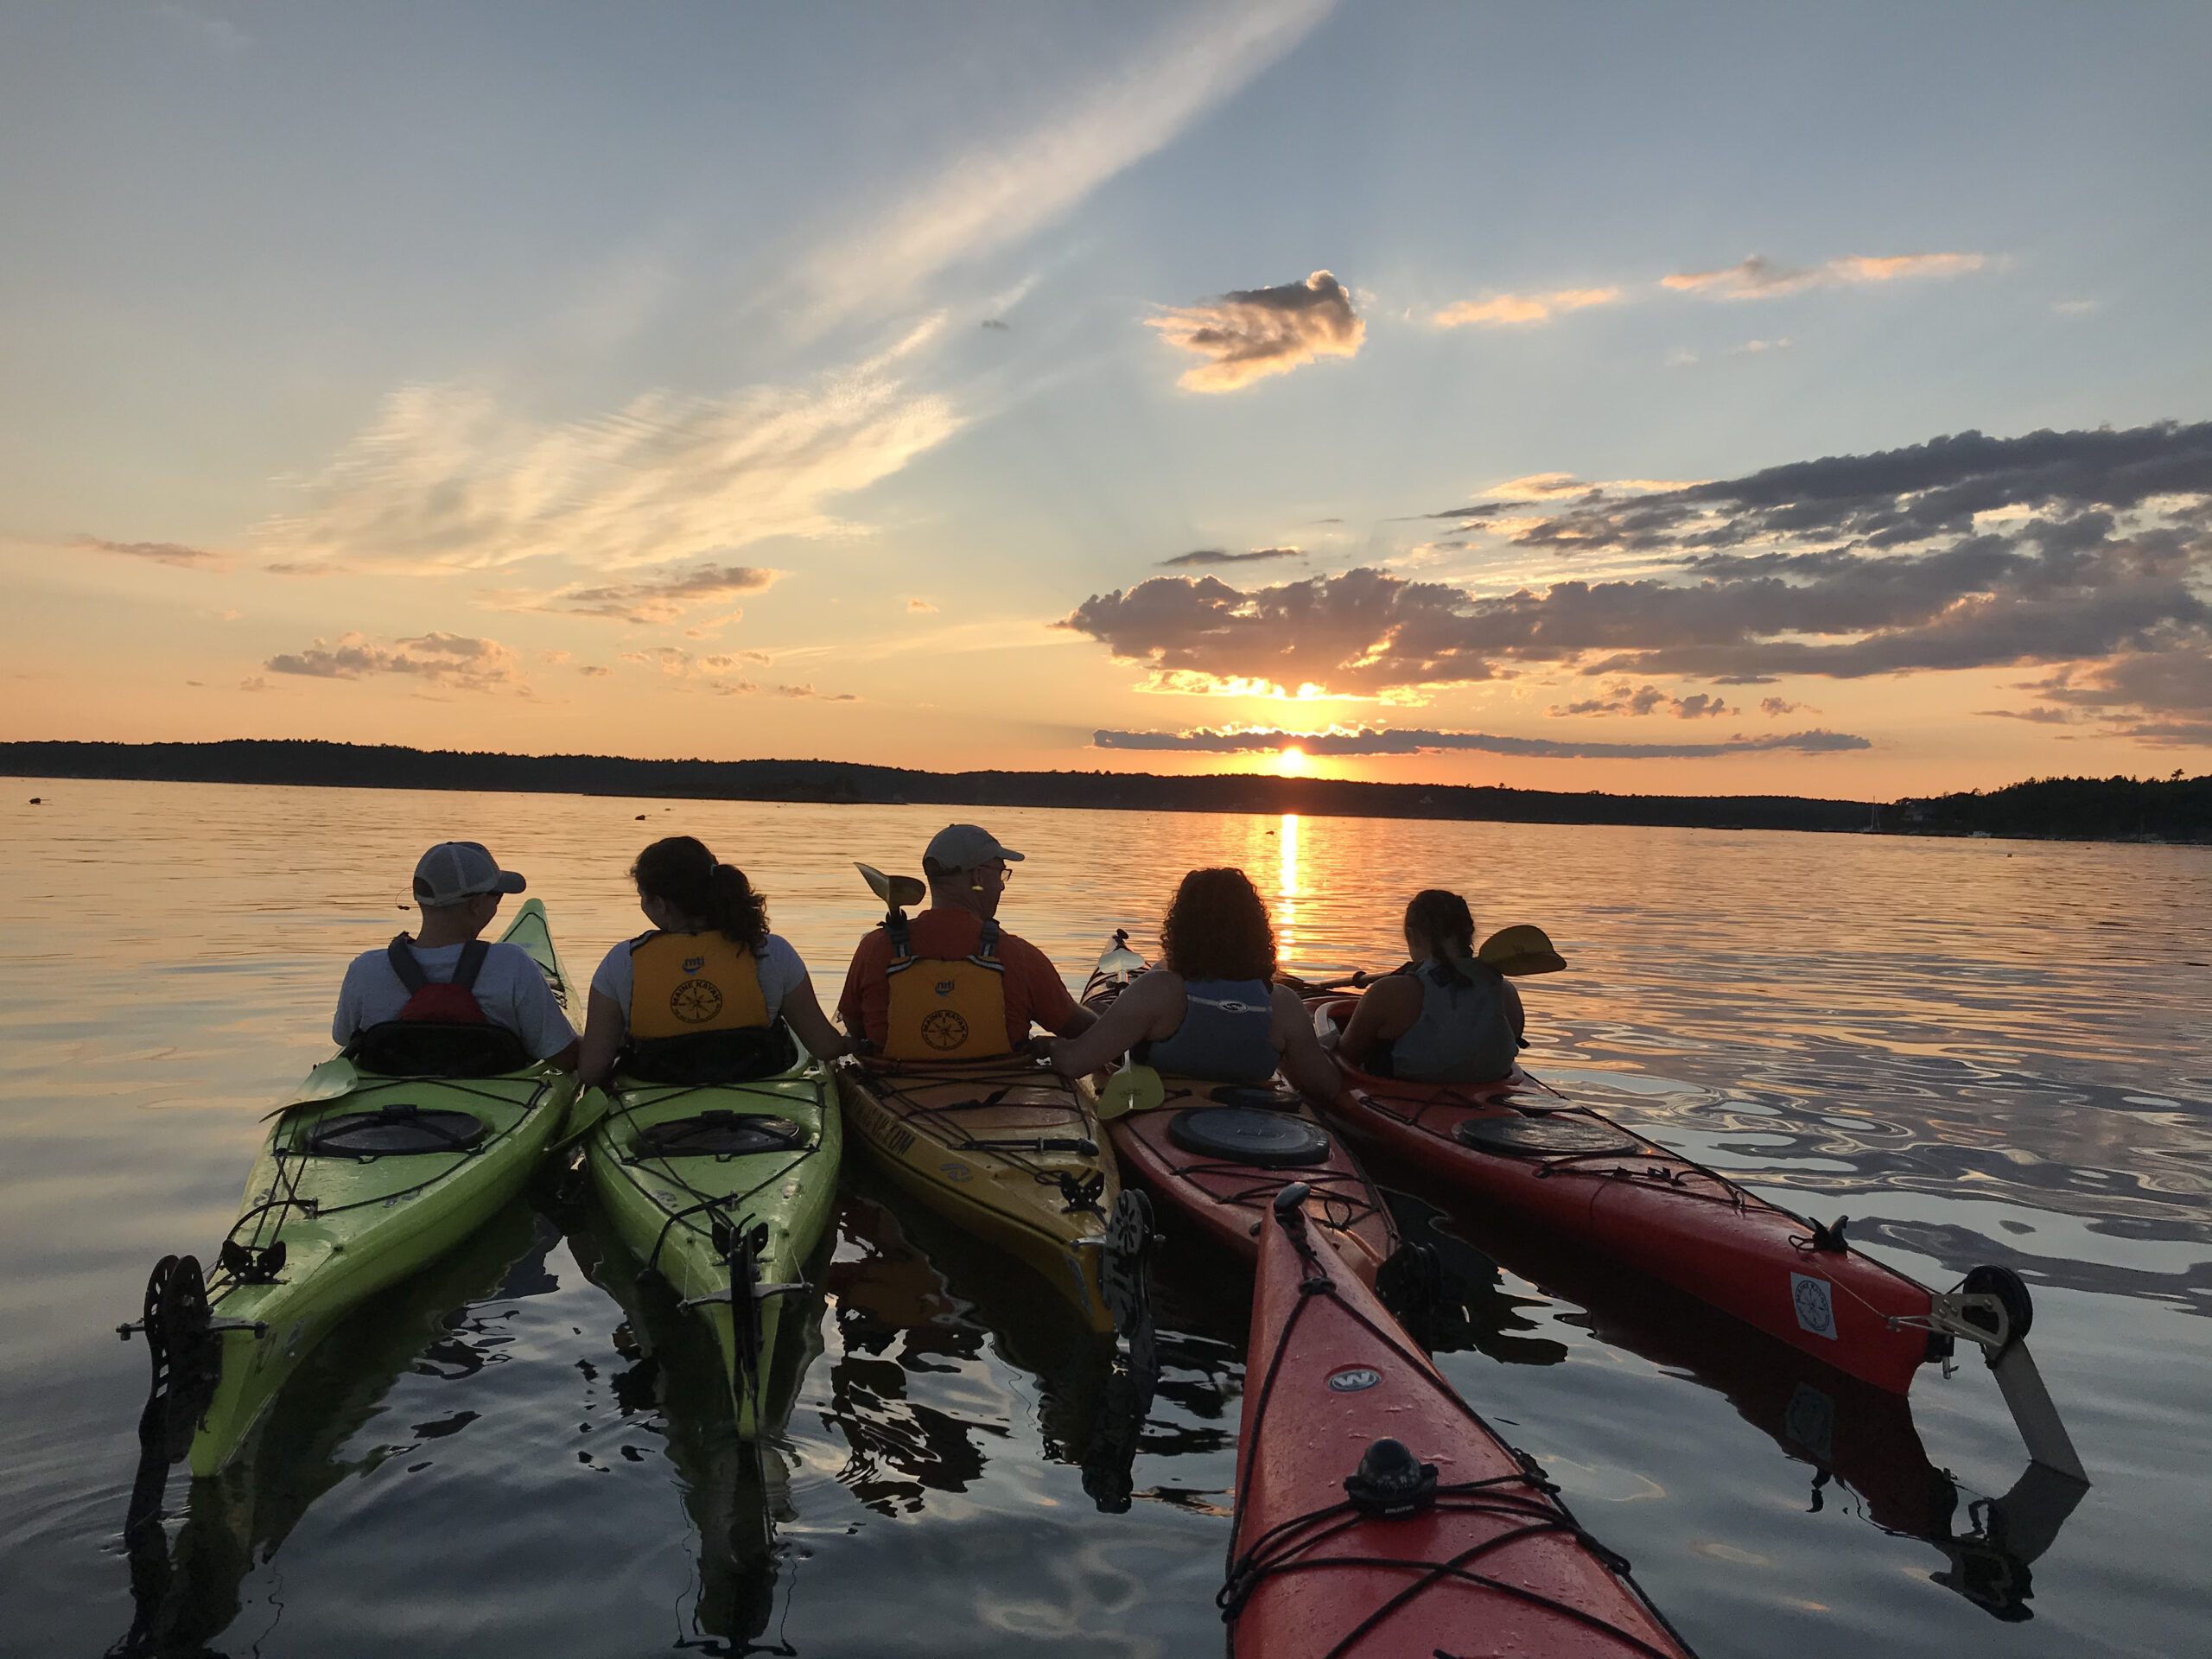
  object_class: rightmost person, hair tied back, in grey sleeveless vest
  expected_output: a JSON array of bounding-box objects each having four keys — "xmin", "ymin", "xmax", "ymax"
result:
[{"xmin": 1336, "ymin": 887, "xmax": 1529, "ymax": 1084}]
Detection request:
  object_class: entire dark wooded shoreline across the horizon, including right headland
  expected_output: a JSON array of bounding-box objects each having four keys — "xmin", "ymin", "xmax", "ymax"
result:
[{"xmin": 0, "ymin": 739, "xmax": 2212, "ymax": 841}]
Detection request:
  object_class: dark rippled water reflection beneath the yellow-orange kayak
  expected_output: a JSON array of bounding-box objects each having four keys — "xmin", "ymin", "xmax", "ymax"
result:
[{"xmin": 825, "ymin": 1173, "xmax": 1148, "ymax": 1516}]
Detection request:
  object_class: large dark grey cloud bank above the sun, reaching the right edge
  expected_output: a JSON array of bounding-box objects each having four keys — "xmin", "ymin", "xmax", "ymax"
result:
[{"xmin": 1059, "ymin": 423, "xmax": 2212, "ymax": 747}]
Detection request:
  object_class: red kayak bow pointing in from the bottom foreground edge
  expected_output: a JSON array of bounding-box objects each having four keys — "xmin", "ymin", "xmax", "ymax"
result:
[{"xmin": 1221, "ymin": 1185, "xmax": 1690, "ymax": 1659}]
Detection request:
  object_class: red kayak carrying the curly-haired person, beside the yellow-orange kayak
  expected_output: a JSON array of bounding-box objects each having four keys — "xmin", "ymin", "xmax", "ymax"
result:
[{"xmin": 1084, "ymin": 933, "xmax": 1398, "ymax": 1287}]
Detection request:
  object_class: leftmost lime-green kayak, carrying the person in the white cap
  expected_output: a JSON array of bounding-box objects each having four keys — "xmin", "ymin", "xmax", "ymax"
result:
[{"xmin": 124, "ymin": 898, "xmax": 575, "ymax": 1476}]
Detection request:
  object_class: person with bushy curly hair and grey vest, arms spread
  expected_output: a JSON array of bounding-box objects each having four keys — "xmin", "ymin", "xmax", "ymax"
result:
[{"xmin": 1051, "ymin": 869, "xmax": 1338, "ymax": 1102}]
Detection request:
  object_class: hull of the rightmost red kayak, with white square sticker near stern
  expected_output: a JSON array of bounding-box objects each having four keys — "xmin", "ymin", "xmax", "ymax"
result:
[{"xmin": 1323, "ymin": 1004, "xmax": 1929, "ymax": 1394}]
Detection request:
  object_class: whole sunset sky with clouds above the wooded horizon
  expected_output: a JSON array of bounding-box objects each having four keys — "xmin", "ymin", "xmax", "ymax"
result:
[{"xmin": 0, "ymin": 0, "xmax": 2212, "ymax": 798}]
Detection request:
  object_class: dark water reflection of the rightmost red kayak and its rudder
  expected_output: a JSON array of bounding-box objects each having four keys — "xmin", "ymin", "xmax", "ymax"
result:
[{"xmin": 1395, "ymin": 1194, "xmax": 2088, "ymax": 1621}]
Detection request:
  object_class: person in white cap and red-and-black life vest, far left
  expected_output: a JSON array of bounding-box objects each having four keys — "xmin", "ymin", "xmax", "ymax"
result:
[{"xmin": 329, "ymin": 841, "xmax": 577, "ymax": 1071}]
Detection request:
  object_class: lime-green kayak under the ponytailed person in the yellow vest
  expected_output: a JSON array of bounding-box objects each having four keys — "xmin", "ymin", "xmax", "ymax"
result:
[{"xmin": 584, "ymin": 1033, "xmax": 845, "ymax": 1438}]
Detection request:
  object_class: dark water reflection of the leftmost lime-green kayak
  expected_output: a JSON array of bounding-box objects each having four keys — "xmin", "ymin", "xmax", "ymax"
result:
[{"xmin": 111, "ymin": 1199, "xmax": 556, "ymax": 1659}]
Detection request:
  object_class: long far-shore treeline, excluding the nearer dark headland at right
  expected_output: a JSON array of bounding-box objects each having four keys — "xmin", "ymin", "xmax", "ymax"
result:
[{"xmin": 0, "ymin": 739, "xmax": 1873, "ymax": 830}]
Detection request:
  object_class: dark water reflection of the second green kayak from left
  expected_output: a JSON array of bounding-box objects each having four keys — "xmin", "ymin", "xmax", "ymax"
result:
[{"xmin": 564, "ymin": 1204, "xmax": 830, "ymax": 1643}]
